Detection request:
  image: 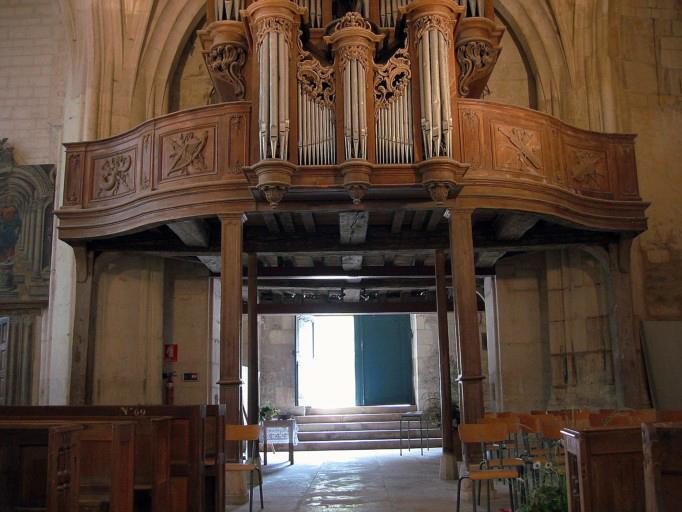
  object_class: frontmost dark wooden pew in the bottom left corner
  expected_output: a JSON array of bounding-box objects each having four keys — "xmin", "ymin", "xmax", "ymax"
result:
[{"xmin": 0, "ymin": 422, "xmax": 83, "ymax": 512}]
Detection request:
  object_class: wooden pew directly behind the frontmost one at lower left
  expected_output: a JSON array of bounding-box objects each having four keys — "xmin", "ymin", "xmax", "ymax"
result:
[{"xmin": 0, "ymin": 419, "xmax": 134, "ymax": 512}]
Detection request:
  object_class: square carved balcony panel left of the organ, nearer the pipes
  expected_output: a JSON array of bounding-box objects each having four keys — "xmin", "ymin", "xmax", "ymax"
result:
[{"xmin": 161, "ymin": 126, "xmax": 216, "ymax": 181}]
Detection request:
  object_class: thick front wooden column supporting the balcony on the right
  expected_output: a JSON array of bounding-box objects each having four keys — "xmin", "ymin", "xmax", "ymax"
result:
[{"xmin": 450, "ymin": 210, "xmax": 483, "ymax": 423}]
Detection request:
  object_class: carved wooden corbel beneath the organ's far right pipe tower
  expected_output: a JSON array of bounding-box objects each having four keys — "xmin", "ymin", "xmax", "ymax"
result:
[{"xmin": 455, "ymin": 18, "xmax": 504, "ymax": 99}]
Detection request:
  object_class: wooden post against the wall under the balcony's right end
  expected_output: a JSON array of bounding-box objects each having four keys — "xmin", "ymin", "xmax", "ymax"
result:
[{"xmin": 609, "ymin": 238, "xmax": 647, "ymax": 409}]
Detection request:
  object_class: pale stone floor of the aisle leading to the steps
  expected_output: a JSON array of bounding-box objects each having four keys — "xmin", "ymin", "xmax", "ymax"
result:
[{"xmin": 227, "ymin": 448, "xmax": 509, "ymax": 512}]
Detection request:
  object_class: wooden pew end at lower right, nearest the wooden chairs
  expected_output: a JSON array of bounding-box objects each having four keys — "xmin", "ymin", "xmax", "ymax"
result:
[{"xmin": 561, "ymin": 425, "xmax": 644, "ymax": 512}]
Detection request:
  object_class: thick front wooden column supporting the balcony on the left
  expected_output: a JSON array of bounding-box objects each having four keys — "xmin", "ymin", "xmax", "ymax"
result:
[{"xmin": 218, "ymin": 213, "xmax": 243, "ymax": 461}]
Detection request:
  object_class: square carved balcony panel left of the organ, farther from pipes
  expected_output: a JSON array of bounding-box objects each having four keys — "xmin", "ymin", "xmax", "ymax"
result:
[{"xmin": 90, "ymin": 149, "xmax": 137, "ymax": 201}]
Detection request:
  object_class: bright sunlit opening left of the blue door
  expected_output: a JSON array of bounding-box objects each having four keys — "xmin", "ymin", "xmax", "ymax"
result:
[{"xmin": 299, "ymin": 315, "xmax": 355, "ymax": 407}]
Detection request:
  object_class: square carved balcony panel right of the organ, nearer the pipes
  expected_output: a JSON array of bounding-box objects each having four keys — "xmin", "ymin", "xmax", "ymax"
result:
[{"xmin": 491, "ymin": 123, "xmax": 543, "ymax": 175}]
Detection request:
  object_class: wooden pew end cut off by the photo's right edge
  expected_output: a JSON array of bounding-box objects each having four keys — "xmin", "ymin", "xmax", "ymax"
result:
[{"xmin": 642, "ymin": 423, "xmax": 682, "ymax": 512}]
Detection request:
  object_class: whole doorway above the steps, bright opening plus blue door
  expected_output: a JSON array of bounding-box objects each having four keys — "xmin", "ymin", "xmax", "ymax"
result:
[{"xmin": 296, "ymin": 315, "xmax": 414, "ymax": 407}]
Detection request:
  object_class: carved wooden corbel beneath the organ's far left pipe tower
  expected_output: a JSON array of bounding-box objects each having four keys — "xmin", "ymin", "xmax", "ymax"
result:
[{"xmin": 197, "ymin": 20, "xmax": 248, "ymax": 101}]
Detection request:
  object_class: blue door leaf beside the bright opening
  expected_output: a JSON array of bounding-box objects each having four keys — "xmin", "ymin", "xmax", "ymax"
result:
[{"xmin": 355, "ymin": 315, "xmax": 414, "ymax": 405}]
